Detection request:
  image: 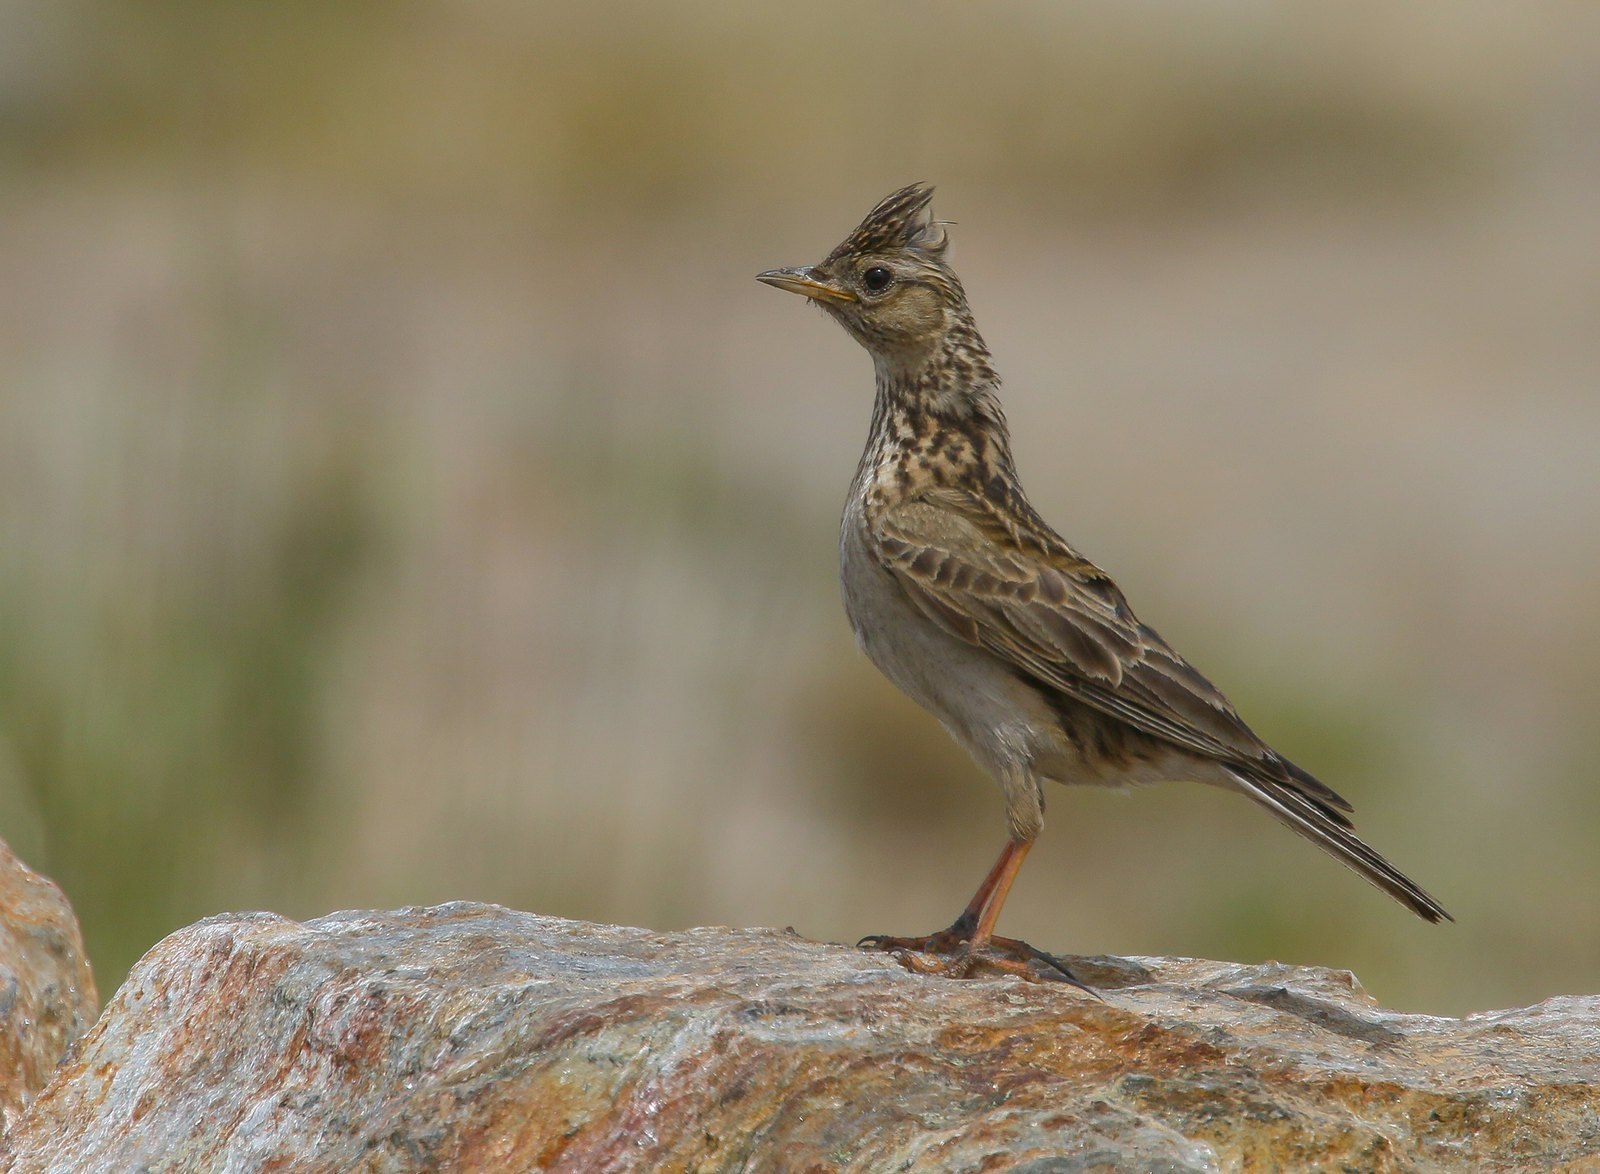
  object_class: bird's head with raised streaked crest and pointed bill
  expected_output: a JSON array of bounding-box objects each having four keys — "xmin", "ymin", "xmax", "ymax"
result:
[{"xmin": 757, "ymin": 184, "xmax": 968, "ymax": 366}]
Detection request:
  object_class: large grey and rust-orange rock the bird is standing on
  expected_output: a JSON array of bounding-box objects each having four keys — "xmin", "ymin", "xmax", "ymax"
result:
[{"xmin": 3, "ymin": 904, "xmax": 1600, "ymax": 1174}]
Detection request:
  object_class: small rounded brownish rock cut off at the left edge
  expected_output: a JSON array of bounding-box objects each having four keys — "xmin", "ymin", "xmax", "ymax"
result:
[{"xmin": 0, "ymin": 841, "xmax": 99, "ymax": 1136}]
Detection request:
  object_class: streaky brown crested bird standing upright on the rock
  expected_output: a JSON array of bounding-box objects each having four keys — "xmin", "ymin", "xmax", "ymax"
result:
[{"xmin": 757, "ymin": 182, "xmax": 1454, "ymax": 990}]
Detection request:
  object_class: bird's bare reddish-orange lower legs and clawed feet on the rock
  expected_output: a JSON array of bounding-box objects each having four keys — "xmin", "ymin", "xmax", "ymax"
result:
[{"xmin": 858, "ymin": 840, "xmax": 1094, "ymax": 995}]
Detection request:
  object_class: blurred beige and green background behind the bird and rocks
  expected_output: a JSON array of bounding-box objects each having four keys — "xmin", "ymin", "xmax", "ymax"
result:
[{"xmin": 0, "ymin": 0, "xmax": 1600, "ymax": 1012}]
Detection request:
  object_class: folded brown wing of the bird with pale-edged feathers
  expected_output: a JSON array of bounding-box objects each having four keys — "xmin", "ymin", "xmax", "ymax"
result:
[{"xmin": 872, "ymin": 491, "xmax": 1350, "ymax": 825}]
